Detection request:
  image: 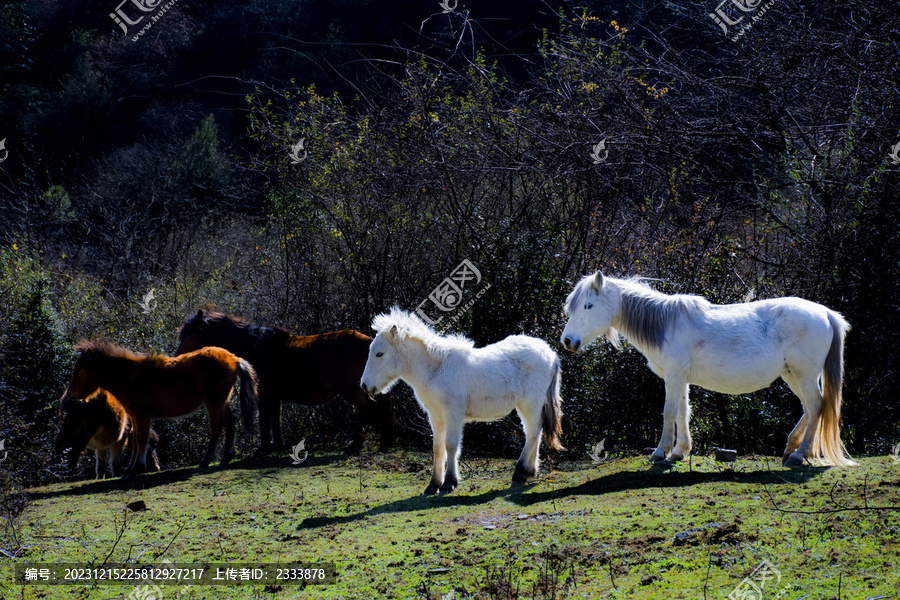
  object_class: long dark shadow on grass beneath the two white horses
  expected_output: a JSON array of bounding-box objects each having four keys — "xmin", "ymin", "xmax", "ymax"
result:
[{"xmin": 297, "ymin": 465, "xmax": 829, "ymax": 530}]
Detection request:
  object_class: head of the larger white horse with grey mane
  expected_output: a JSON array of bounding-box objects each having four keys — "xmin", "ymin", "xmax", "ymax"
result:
[{"xmin": 560, "ymin": 271, "xmax": 620, "ymax": 352}]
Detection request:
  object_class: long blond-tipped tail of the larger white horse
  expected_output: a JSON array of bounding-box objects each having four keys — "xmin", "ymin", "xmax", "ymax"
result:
[{"xmin": 812, "ymin": 311, "xmax": 858, "ymax": 467}]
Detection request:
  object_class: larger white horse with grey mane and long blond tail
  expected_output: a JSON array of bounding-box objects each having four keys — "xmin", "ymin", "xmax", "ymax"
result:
[{"xmin": 561, "ymin": 271, "xmax": 857, "ymax": 466}]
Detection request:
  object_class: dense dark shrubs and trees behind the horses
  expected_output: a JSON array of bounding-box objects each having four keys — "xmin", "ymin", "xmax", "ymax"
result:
[{"xmin": 0, "ymin": 0, "xmax": 900, "ymax": 486}]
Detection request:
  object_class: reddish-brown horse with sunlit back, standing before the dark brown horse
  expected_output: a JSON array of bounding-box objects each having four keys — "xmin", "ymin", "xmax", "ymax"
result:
[{"xmin": 63, "ymin": 341, "xmax": 257, "ymax": 477}]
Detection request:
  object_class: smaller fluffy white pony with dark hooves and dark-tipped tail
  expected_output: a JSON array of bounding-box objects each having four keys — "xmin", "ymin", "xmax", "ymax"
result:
[{"xmin": 360, "ymin": 308, "xmax": 563, "ymax": 494}]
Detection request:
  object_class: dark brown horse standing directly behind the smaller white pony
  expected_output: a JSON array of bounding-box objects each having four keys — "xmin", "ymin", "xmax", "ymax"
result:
[{"xmin": 175, "ymin": 310, "xmax": 394, "ymax": 452}]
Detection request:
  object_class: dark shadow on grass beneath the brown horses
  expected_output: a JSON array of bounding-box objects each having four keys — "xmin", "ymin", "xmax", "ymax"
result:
[{"xmin": 26, "ymin": 451, "xmax": 351, "ymax": 500}]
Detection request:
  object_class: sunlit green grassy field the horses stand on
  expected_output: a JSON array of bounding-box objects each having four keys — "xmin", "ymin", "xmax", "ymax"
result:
[{"xmin": 0, "ymin": 452, "xmax": 900, "ymax": 600}]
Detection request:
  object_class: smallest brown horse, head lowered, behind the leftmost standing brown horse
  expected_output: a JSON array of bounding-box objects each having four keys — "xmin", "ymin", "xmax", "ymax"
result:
[{"xmin": 54, "ymin": 390, "xmax": 159, "ymax": 479}]
